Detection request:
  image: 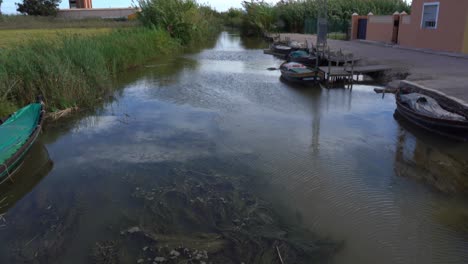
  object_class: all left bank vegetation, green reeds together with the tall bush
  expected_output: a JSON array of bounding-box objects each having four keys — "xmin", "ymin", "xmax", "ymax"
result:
[{"xmin": 0, "ymin": 0, "xmax": 221, "ymax": 116}]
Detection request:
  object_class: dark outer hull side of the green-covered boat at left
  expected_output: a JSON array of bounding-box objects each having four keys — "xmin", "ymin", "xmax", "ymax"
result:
[{"xmin": 0, "ymin": 104, "xmax": 45, "ymax": 180}]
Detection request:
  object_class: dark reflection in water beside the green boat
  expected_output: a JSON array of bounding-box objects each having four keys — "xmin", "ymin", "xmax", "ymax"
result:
[{"xmin": 0, "ymin": 141, "xmax": 53, "ymax": 214}]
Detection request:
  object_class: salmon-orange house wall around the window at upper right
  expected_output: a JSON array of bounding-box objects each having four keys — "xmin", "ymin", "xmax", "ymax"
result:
[{"xmin": 398, "ymin": 0, "xmax": 468, "ymax": 52}]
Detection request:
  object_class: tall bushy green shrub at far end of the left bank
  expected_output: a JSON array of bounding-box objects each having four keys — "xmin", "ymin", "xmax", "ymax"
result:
[{"xmin": 138, "ymin": 0, "xmax": 221, "ymax": 44}]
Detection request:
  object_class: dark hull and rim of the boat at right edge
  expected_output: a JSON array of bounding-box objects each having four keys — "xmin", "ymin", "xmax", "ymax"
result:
[{"xmin": 396, "ymin": 85, "xmax": 468, "ymax": 141}]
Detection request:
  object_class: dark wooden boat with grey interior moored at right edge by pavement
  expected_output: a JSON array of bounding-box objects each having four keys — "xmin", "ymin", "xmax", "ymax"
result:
[{"xmin": 395, "ymin": 83, "xmax": 468, "ymax": 141}]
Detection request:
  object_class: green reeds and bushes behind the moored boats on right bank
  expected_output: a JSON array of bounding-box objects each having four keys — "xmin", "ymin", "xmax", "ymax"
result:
[{"xmin": 223, "ymin": 0, "xmax": 410, "ymax": 35}]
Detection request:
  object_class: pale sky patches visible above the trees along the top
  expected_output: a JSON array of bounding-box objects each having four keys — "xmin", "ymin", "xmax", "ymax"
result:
[{"xmin": 2, "ymin": 0, "xmax": 277, "ymax": 14}]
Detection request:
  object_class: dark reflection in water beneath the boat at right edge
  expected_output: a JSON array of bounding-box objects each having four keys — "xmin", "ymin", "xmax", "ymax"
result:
[{"xmin": 395, "ymin": 129, "xmax": 468, "ymax": 193}]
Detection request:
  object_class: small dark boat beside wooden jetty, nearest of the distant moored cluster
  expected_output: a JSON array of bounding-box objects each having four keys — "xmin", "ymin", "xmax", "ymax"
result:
[{"xmin": 280, "ymin": 62, "xmax": 323, "ymax": 84}]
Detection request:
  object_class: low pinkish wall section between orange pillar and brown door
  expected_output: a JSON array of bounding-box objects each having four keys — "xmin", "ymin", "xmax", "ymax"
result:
[{"xmin": 366, "ymin": 16, "xmax": 394, "ymax": 43}]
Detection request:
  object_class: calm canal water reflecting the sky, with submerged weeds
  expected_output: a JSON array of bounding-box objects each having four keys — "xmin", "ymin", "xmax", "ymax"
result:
[{"xmin": 0, "ymin": 32, "xmax": 468, "ymax": 264}]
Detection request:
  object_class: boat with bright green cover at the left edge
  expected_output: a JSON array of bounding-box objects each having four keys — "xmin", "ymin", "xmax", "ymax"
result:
[{"xmin": 0, "ymin": 103, "xmax": 44, "ymax": 182}]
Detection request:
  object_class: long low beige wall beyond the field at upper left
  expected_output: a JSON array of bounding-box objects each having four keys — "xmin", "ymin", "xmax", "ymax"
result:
[{"xmin": 57, "ymin": 8, "xmax": 137, "ymax": 19}]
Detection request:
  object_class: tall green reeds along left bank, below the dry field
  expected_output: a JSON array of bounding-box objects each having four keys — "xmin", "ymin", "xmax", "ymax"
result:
[{"xmin": 0, "ymin": 28, "xmax": 180, "ymax": 113}]
